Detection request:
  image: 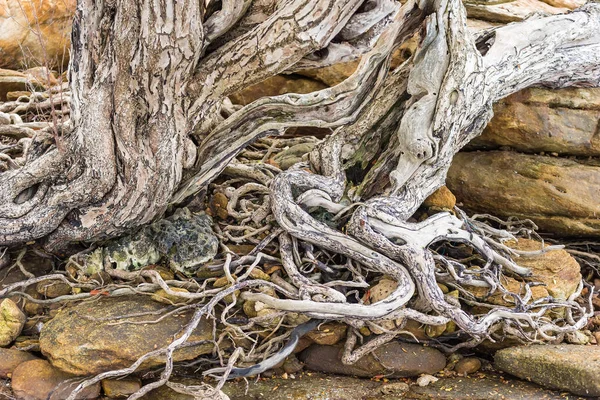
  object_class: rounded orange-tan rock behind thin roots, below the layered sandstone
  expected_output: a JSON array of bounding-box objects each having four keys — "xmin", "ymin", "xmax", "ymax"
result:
[{"xmin": 466, "ymin": 238, "xmax": 582, "ymax": 307}]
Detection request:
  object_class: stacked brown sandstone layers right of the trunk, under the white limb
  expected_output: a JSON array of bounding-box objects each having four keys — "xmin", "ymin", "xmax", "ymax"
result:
[{"xmin": 447, "ymin": 88, "xmax": 600, "ymax": 237}]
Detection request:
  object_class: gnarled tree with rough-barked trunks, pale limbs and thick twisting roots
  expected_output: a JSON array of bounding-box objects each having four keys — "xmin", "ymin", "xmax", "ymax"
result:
[{"xmin": 0, "ymin": 0, "xmax": 600, "ymax": 396}]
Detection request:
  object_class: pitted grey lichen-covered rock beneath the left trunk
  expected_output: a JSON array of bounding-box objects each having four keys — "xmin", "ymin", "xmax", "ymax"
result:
[{"xmin": 85, "ymin": 208, "xmax": 219, "ymax": 275}]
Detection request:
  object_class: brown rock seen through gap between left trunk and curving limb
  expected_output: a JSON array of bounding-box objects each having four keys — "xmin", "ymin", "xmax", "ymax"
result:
[{"xmin": 230, "ymin": 75, "xmax": 327, "ymax": 105}]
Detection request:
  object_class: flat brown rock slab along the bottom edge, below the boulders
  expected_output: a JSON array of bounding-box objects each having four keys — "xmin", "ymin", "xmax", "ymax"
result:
[{"xmin": 139, "ymin": 372, "xmax": 577, "ymax": 400}]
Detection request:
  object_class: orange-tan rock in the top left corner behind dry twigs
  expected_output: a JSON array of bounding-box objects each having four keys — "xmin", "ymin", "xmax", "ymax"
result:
[{"xmin": 0, "ymin": 0, "xmax": 77, "ymax": 69}]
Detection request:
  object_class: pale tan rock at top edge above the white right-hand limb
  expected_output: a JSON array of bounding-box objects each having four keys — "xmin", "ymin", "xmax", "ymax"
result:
[{"xmin": 464, "ymin": 0, "xmax": 569, "ymax": 23}]
